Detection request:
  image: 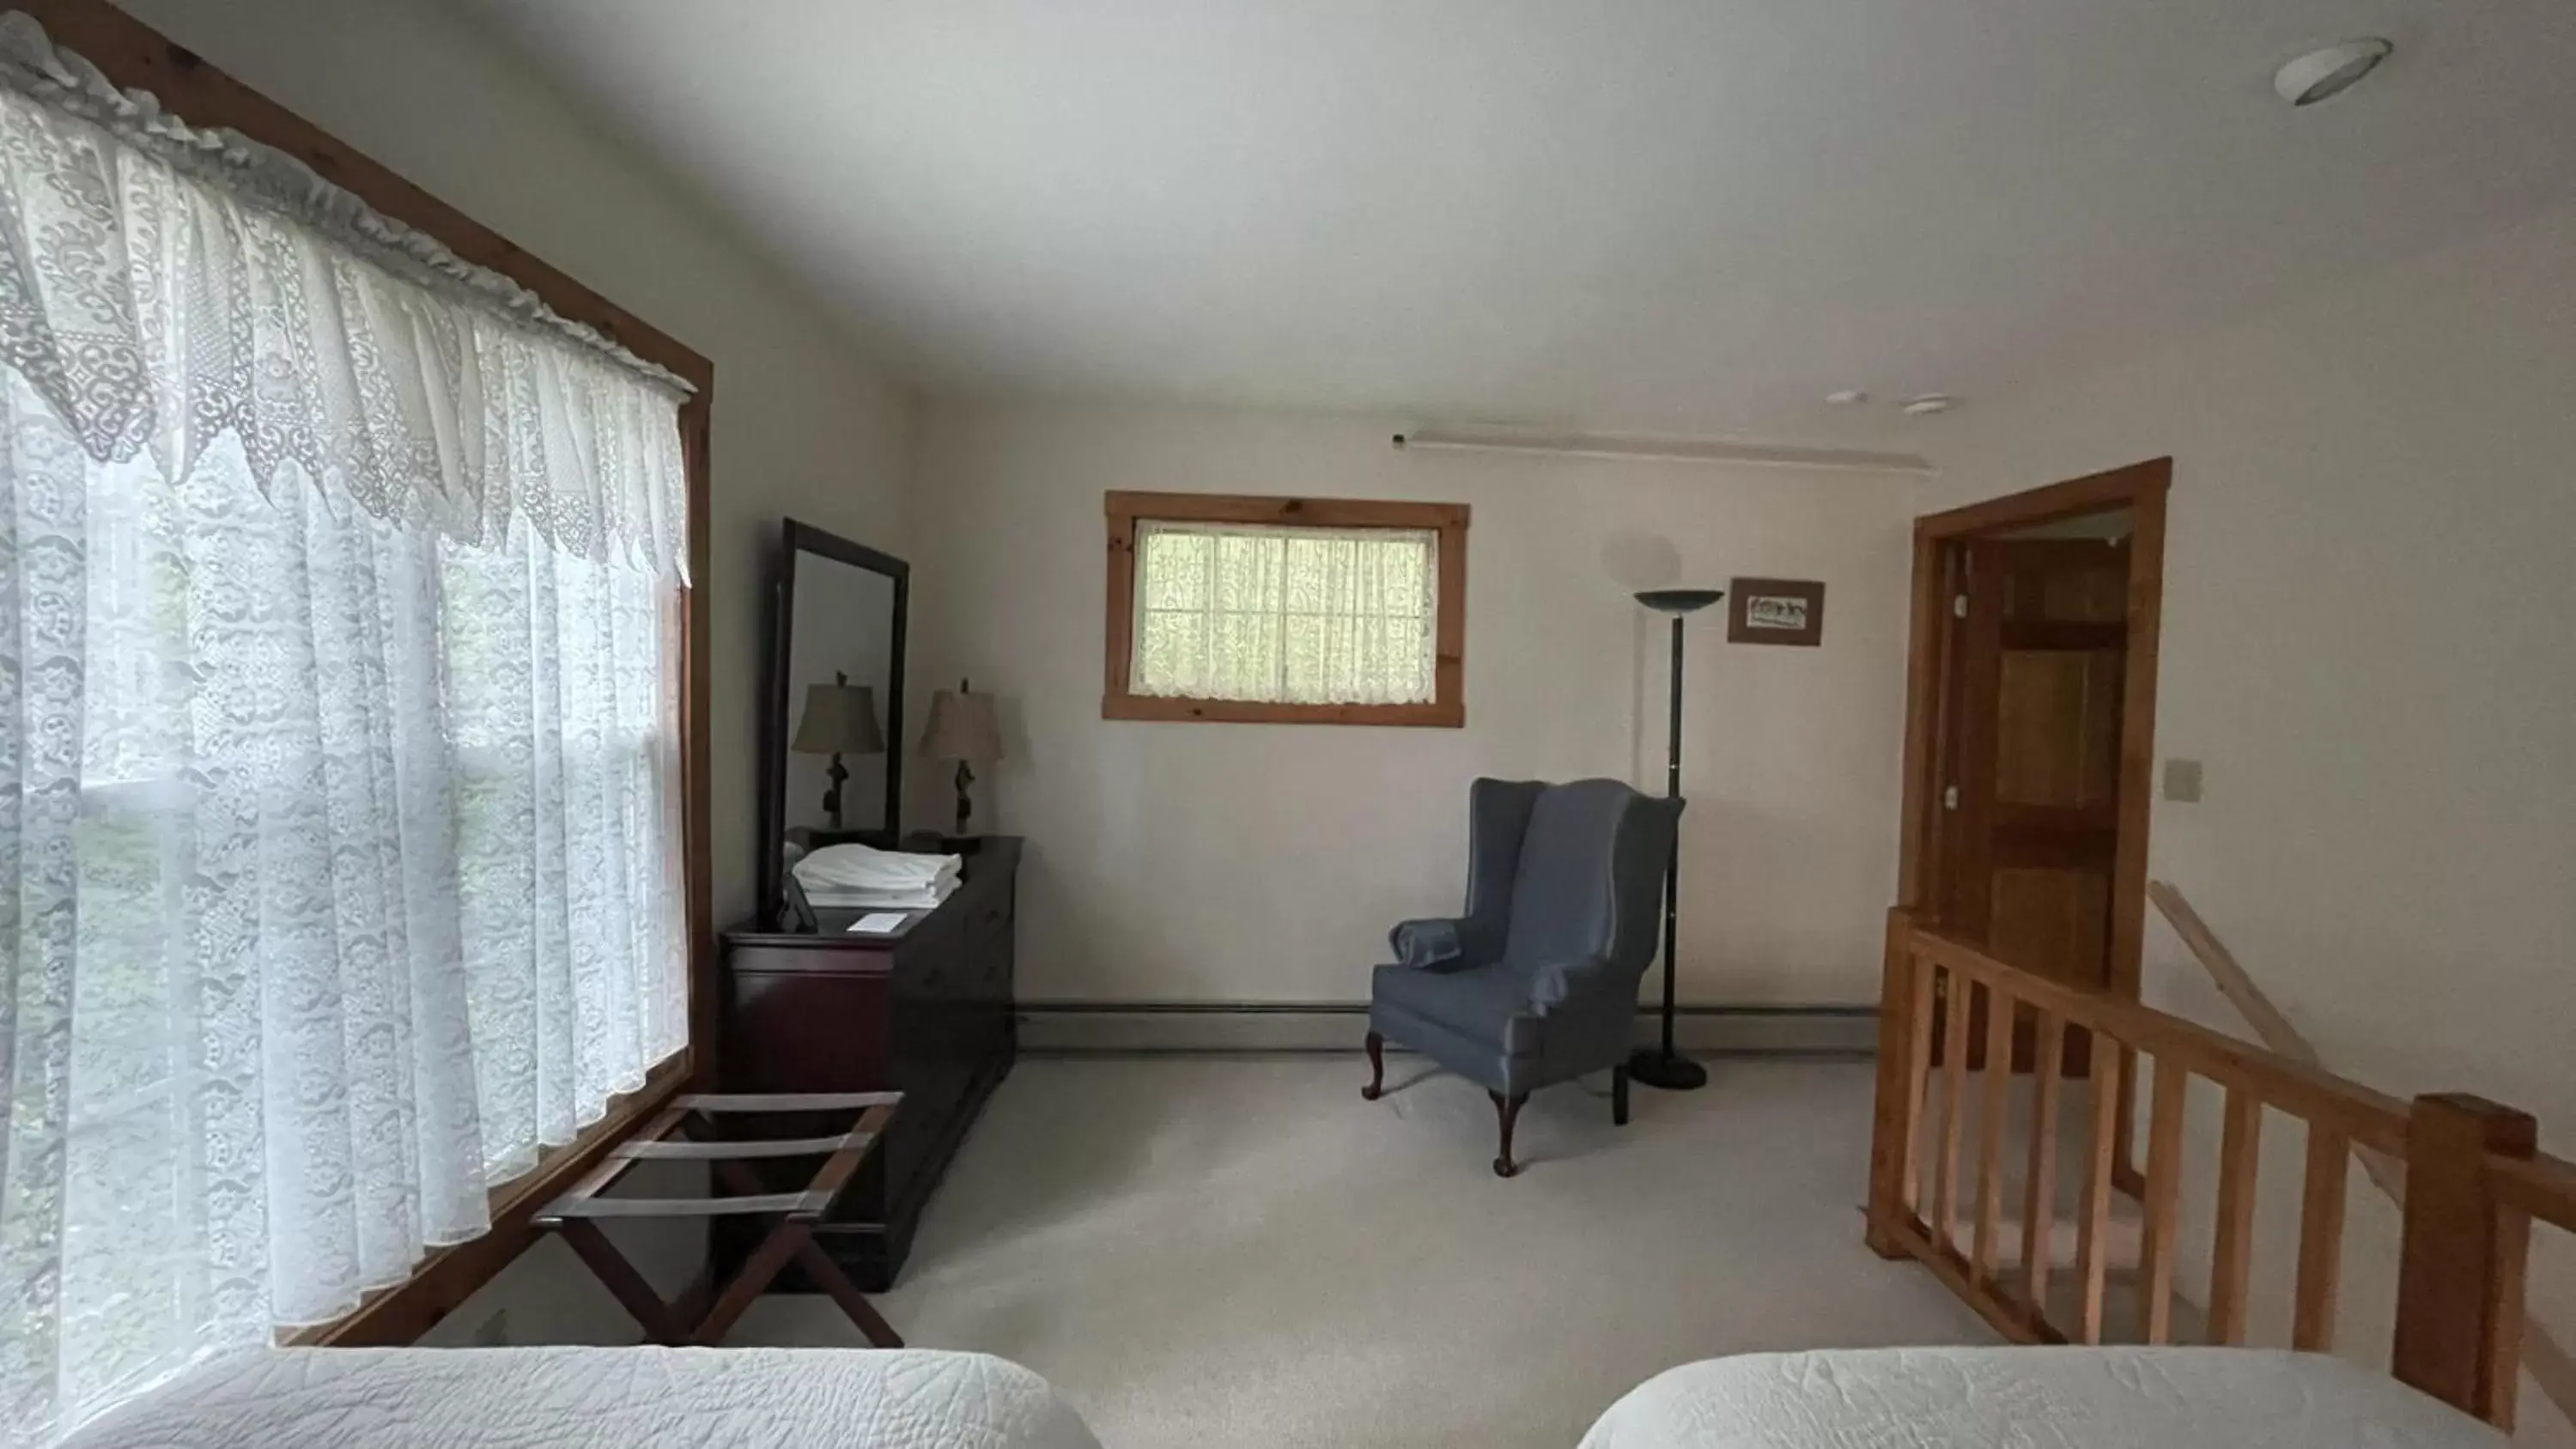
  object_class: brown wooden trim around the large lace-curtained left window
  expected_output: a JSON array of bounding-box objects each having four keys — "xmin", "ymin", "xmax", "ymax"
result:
[{"xmin": 8, "ymin": 0, "xmax": 716, "ymax": 1346}]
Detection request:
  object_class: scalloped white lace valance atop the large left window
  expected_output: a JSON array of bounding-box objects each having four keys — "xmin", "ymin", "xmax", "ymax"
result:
[{"xmin": 0, "ymin": 13, "xmax": 688, "ymax": 577}]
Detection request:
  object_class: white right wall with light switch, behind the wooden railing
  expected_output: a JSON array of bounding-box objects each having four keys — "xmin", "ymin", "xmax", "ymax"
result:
[{"xmin": 1927, "ymin": 200, "xmax": 2576, "ymax": 1441}]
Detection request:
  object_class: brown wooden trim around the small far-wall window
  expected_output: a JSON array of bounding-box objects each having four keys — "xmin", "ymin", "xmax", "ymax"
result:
[{"xmin": 1100, "ymin": 492, "xmax": 1471, "ymax": 728}]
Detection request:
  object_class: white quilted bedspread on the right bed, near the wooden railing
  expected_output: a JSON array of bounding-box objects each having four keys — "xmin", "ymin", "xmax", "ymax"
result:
[{"xmin": 1582, "ymin": 1349, "xmax": 2504, "ymax": 1449}]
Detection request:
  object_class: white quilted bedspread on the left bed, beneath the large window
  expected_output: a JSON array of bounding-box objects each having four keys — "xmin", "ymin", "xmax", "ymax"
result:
[{"xmin": 67, "ymin": 1349, "xmax": 1100, "ymax": 1449}]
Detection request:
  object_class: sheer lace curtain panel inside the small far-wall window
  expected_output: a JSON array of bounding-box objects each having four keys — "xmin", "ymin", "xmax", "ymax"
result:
[{"xmin": 1128, "ymin": 520, "xmax": 1440, "ymax": 706}]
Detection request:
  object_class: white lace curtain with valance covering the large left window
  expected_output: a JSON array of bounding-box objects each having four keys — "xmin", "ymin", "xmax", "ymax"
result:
[{"xmin": 0, "ymin": 18, "xmax": 688, "ymax": 1441}]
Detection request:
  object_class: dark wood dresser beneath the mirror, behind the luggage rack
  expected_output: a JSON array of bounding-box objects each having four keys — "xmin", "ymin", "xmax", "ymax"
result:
[{"xmin": 716, "ymin": 836, "xmax": 1020, "ymax": 1292}]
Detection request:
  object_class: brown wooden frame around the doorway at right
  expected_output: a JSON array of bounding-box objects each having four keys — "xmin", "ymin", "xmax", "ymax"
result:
[{"xmin": 1896, "ymin": 458, "xmax": 2174, "ymax": 1001}]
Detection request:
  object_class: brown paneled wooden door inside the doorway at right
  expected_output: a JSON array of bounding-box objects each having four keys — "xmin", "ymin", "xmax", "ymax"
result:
[{"xmin": 1932, "ymin": 538, "xmax": 2130, "ymax": 1070}]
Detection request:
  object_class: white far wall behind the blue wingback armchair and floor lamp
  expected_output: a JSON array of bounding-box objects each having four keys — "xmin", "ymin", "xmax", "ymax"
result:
[{"xmin": 907, "ymin": 404, "xmax": 1917, "ymax": 1003}]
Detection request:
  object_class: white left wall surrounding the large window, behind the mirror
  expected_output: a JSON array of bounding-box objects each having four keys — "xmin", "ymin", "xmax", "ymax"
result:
[{"xmin": 106, "ymin": 0, "xmax": 909, "ymax": 1343}]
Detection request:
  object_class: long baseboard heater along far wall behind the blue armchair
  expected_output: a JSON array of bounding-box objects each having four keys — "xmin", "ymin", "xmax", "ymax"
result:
[{"xmin": 1020, "ymin": 1001, "xmax": 1878, "ymax": 1058}]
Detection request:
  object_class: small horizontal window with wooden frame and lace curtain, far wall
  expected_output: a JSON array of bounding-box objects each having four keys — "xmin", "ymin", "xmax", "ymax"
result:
[{"xmin": 1100, "ymin": 494, "xmax": 1468, "ymax": 728}]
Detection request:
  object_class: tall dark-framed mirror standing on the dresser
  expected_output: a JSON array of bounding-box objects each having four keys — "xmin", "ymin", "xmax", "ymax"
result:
[{"xmin": 760, "ymin": 518, "xmax": 912, "ymax": 929}]
